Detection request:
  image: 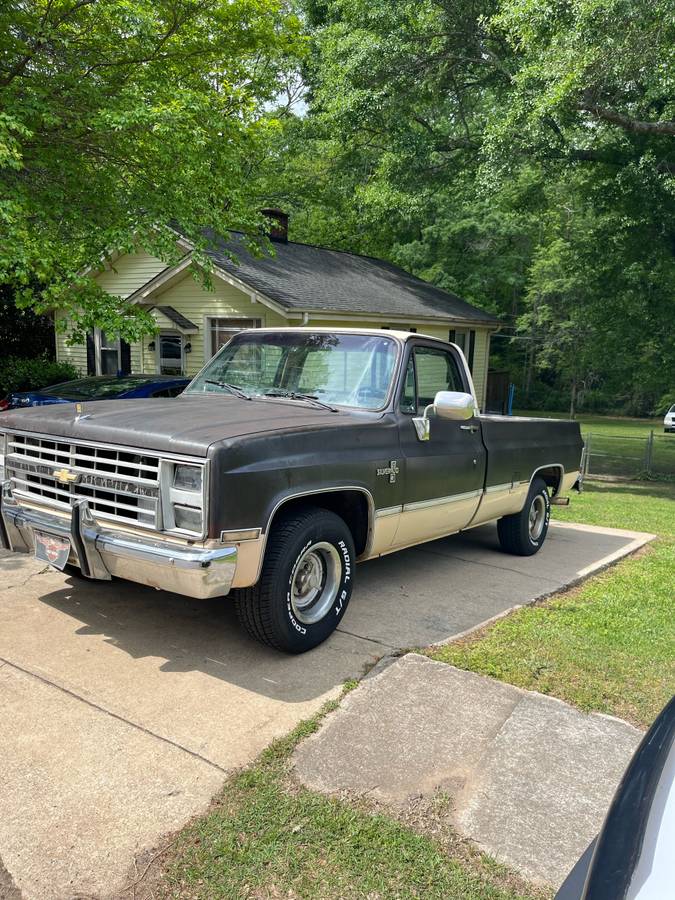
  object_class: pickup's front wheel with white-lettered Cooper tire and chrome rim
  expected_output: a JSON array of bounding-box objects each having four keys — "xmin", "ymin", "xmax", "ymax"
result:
[{"xmin": 235, "ymin": 509, "xmax": 355, "ymax": 653}]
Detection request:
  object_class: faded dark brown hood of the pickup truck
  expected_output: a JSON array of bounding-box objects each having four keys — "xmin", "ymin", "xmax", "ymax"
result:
[{"xmin": 0, "ymin": 395, "xmax": 363, "ymax": 456}]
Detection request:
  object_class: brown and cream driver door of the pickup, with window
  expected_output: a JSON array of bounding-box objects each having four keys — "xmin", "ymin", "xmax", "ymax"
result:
[{"xmin": 394, "ymin": 342, "xmax": 486, "ymax": 547}]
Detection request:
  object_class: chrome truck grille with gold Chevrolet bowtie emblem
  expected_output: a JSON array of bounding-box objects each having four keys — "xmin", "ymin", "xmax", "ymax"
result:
[{"xmin": 5, "ymin": 434, "xmax": 160, "ymax": 529}]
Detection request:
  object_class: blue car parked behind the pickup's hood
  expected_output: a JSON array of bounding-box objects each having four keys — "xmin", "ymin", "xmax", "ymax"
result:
[{"xmin": 0, "ymin": 375, "xmax": 190, "ymax": 412}]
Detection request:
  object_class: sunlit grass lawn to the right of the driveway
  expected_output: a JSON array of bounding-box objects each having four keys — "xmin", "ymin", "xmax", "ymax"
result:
[{"xmin": 429, "ymin": 483, "xmax": 675, "ymax": 726}]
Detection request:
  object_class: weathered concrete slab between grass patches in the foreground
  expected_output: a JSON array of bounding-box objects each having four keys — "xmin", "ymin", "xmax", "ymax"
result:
[{"xmin": 294, "ymin": 653, "xmax": 642, "ymax": 888}]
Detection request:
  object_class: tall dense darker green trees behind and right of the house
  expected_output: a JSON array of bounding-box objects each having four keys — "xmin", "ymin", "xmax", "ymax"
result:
[{"xmin": 274, "ymin": 0, "xmax": 675, "ymax": 412}]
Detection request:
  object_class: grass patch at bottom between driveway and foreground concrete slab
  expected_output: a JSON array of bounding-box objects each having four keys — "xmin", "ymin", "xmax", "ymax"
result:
[{"xmin": 160, "ymin": 704, "xmax": 548, "ymax": 900}]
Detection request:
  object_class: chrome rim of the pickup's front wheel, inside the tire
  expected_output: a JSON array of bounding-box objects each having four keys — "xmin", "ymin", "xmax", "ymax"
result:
[{"xmin": 290, "ymin": 541, "xmax": 342, "ymax": 625}]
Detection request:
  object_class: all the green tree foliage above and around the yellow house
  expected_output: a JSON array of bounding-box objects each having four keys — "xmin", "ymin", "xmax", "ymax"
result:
[{"xmin": 0, "ymin": 0, "xmax": 675, "ymax": 412}]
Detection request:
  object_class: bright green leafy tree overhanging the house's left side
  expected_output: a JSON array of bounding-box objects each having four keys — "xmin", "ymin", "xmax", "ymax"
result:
[{"xmin": 0, "ymin": 0, "xmax": 300, "ymax": 340}]
